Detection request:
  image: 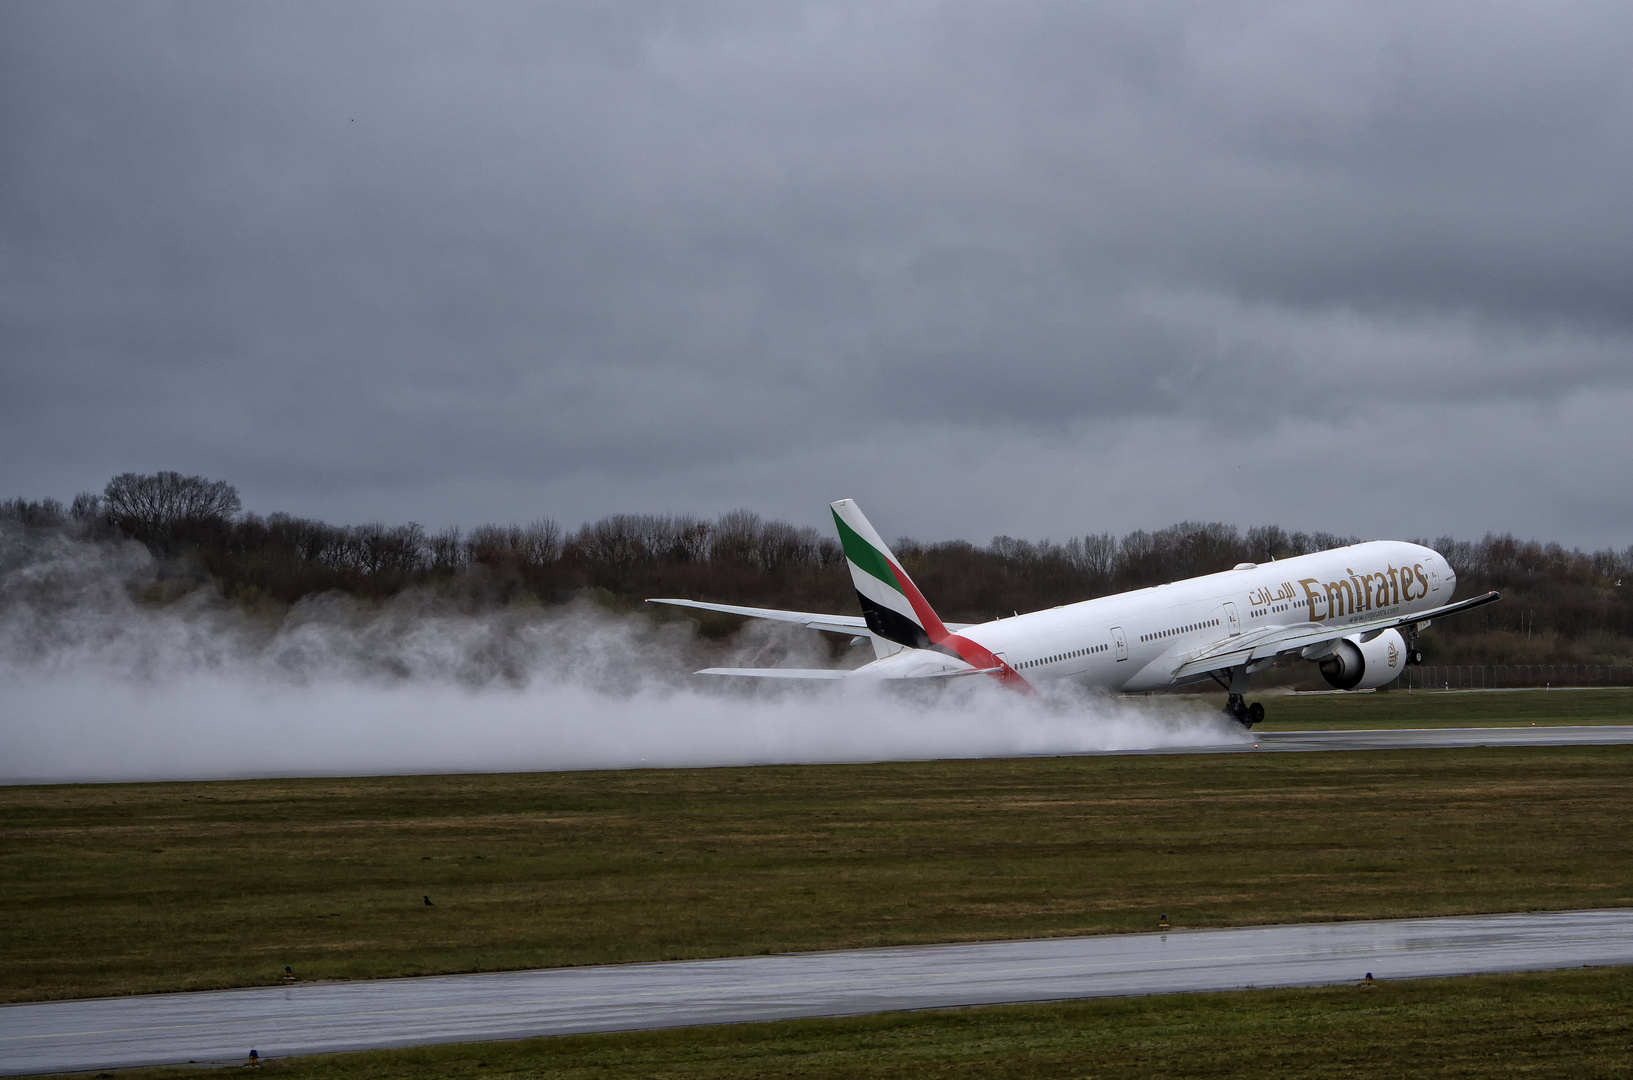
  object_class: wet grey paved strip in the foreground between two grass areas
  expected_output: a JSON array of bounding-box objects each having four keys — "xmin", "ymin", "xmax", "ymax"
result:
[{"xmin": 0, "ymin": 908, "xmax": 1633, "ymax": 1073}]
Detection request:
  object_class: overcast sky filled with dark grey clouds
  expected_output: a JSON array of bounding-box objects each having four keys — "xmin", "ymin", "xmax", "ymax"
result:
[{"xmin": 0, "ymin": 0, "xmax": 1633, "ymax": 547}]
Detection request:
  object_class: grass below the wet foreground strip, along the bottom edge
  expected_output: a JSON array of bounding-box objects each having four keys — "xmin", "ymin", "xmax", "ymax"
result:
[{"xmin": 35, "ymin": 967, "xmax": 1633, "ymax": 1080}]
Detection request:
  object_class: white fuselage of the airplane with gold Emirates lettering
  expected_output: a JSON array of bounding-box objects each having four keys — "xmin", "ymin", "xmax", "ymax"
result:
[{"xmin": 947, "ymin": 541, "xmax": 1457, "ymax": 691}]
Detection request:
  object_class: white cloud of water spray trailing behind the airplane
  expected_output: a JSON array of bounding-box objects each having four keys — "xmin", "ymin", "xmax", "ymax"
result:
[{"xmin": 0, "ymin": 526, "xmax": 1246, "ymax": 783}]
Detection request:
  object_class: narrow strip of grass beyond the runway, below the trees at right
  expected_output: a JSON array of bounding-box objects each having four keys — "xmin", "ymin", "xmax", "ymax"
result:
[{"xmin": 1251, "ymin": 688, "xmax": 1633, "ymax": 732}]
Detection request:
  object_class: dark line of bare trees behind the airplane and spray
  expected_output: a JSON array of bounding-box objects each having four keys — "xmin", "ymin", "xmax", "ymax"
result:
[{"xmin": 0, "ymin": 472, "xmax": 1633, "ymax": 663}]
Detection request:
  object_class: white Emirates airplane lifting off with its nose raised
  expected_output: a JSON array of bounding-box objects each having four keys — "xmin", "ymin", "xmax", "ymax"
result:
[{"xmin": 647, "ymin": 498, "xmax": 1499, "ymax": 727}]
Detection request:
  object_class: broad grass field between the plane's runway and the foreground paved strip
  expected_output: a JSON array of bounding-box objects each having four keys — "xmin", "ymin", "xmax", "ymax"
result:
[{"xmin": 0, "ymin": 741, "xmax": 1633, "ymax": 1000}]
